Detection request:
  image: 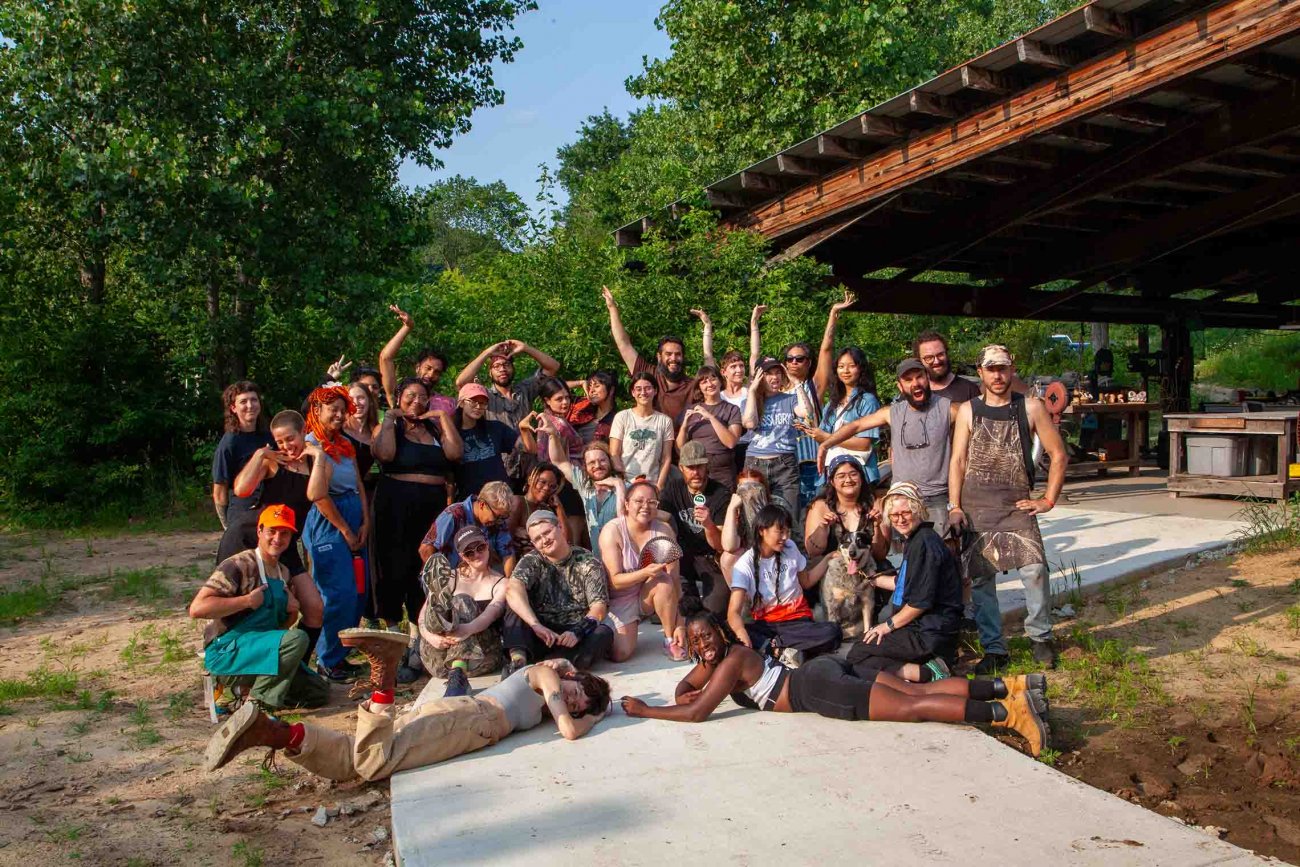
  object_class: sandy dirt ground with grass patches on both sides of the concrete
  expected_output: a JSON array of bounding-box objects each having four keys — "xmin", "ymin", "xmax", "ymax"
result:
[{"xmin": 0, "ymin": 533, "xmax": 1300, "ymax": 864}]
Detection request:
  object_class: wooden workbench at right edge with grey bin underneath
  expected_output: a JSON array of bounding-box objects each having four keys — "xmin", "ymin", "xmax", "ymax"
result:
[{"xmin": 1165, "ymin": 408, "xmax": 1300, "ymax": 499}]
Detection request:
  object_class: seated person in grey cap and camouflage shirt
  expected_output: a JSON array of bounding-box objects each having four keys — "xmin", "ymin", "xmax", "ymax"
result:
[{"xmin": 502, "ymin": 510, "xmax": 614, "ymax": 679}]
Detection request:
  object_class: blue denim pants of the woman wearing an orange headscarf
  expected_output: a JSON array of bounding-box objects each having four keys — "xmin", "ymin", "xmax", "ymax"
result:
[{"xmin": 303, "ymin": 494, "xmax": 371, "ymax": 668}]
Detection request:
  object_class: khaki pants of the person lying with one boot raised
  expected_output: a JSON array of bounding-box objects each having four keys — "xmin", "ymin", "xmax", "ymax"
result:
[{"xmin": 292, "ymin": 695, "xmax": 510, "ymax": 780}]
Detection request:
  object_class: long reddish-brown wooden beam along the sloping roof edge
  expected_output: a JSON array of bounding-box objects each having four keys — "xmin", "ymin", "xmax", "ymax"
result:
[{"xmin": 733, "ymin": 0, "xmax": 1300, "ymax": 243}]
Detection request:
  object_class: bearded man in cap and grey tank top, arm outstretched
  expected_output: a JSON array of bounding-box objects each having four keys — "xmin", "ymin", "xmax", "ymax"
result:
[{"xmin": 818, "ymin": 359, "xmax": 957, "ymax": 537}]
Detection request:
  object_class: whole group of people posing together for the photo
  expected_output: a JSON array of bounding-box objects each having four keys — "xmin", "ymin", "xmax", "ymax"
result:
[{"xmin": 190, "ymin": 289, "xmax": 1066, "ymax": 779}]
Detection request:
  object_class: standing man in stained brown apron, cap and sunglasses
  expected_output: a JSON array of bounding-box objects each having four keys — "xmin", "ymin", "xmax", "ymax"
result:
[{"xmin": 948, "ymin": 344, "xmax": 1066, "ymax": 675}]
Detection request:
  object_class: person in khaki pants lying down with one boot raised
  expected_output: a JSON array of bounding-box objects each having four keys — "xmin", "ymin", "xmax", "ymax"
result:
[{"xmin": 204, "ymin": 629, "xmax": 610, "ymax": 781}]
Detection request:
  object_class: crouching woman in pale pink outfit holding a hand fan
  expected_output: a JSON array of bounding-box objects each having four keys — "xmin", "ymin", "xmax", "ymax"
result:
[{"xmin": 601, "ymin": 481, "xmax": 686, "ymax": 663}]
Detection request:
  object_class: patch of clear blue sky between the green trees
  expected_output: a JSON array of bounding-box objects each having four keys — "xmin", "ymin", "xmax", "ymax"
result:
[{"xmin": 400, "ymin": 0, "xmax": 668, "ymax": 205}]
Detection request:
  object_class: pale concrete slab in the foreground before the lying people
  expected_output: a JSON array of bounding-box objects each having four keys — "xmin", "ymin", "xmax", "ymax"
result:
[{"xmin": 393, "ymin": 627, "xmax": 1264, "ymax": 867}]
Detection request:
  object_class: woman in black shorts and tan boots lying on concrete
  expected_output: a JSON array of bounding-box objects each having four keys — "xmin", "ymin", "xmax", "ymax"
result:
[{"xmin": 619, "ymin": 611, "xmax": 1050, "ymax": 757}]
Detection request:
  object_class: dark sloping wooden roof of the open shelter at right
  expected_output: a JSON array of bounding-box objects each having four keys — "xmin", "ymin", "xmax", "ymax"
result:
[{"xmin": 615, "ymin": 0, "xmax": 1300, "ymax": 328}]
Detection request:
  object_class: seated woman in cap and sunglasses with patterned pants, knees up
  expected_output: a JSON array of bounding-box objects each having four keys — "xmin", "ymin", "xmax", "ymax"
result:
[{"xmin": 419, "ymin": 526, "xmax": 506, "ymax": 698}]
